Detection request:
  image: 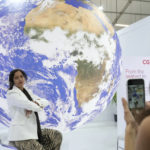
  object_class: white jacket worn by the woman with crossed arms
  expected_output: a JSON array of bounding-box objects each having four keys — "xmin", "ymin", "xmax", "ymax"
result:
[{"xmin": 7, "ymin": 86, "xmax": 49, "ymax": 141}]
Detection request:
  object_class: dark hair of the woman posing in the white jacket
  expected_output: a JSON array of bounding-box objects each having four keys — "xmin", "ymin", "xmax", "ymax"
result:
[{"xmin": 9, "ymin": 69, "xmax": 27, "ymax": 90}]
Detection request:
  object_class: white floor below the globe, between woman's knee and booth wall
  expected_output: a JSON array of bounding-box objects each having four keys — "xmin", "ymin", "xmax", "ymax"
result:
[{"xmin": 61, "ymin": 122, "xmax": 117, "ymax": 150}]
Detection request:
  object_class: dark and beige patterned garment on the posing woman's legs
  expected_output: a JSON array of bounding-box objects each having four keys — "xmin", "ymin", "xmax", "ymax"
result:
[{"xmin": 13, "ymin": 129, "xmax": 62, "ymax": 150}]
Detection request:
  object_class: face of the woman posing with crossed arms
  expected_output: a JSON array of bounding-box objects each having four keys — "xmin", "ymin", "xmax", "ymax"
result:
[{"xmin": 13, "ymin": 71, "xmax": 25, "ymax": 90}]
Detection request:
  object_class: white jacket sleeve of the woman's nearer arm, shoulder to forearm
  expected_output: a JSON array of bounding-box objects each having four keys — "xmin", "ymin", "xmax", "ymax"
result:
[{"xmin": 7, "ymin": 92, "xmax": 43, "ymax": 112}]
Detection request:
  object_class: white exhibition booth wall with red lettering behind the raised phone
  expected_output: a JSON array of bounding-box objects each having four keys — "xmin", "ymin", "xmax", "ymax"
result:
[{"xmin": 117, "ymin": 17, "xmax": 150, "ymax": 149}]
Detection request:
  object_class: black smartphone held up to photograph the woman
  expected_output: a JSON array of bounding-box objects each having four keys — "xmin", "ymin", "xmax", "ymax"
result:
[{"xmin": 127, "ymin": 79, "xmax": 145, "ymax": 110}]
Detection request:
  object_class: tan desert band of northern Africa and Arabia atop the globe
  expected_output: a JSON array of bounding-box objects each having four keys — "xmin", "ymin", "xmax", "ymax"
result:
[{"xmin": 25, "ymin": 0, "xmax": 114, "ymax": 35}]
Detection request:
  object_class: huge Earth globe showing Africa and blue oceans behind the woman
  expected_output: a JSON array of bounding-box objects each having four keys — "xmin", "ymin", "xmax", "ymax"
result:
[{"xmin": 0, "ymin": 0, "xmax": 121, "ymax": 132}]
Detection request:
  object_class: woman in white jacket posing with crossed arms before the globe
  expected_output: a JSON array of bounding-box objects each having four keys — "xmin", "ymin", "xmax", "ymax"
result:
[{"xmin": 7, "ymin": 69, "xmax": 62, "ymax": 150}]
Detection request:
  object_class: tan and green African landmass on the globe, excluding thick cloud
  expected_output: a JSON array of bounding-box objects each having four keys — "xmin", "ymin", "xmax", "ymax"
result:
[{"xmin": 24, "ymin": 0, "xmax": 116, "ymax": 106}]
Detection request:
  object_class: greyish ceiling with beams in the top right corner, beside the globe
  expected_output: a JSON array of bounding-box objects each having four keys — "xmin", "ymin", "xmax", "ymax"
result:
[{"xmin": 91, "ymin": 0, "xmax": 150, "ymax": 30}]
